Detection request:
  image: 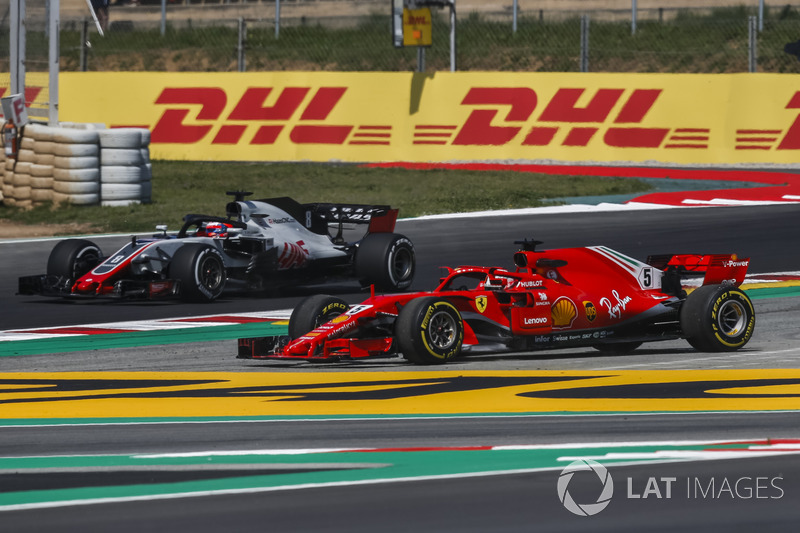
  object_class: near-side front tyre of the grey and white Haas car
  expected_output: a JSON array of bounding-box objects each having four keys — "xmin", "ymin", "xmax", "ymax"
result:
[{"xmin": 169, "ymin": 244, "xmax": 227, "ymax": 302}]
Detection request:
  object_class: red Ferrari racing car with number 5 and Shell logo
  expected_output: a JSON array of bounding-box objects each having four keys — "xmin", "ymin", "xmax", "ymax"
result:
[{"xmin": 239, "ymin": 241, "xmax": 755, "ymax": 364}]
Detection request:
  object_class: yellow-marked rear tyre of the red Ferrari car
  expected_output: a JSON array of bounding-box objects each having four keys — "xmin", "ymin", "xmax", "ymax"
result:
[{"xmin": 680, "ymin": 285, "xmax": 756, "ymax": 352}]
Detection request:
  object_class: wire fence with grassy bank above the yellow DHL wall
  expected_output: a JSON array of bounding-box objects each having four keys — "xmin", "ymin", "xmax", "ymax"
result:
[{"xmin": 0, "ymin": 0, "xmax": 800, "ymax": 73}]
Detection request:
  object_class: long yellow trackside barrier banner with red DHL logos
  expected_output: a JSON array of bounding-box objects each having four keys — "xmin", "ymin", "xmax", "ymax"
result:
[{"xmin": 47, "ymin": 72, "xmax": 800, "ymax": 164}]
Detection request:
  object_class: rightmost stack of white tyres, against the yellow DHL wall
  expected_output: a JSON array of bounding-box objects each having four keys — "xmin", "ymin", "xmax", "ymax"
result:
[{"xmin": 99, "ymin": 128, "xmax": 152, "ymax": 206}]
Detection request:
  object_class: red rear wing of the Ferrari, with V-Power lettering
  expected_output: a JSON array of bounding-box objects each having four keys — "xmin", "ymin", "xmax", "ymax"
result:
[{"xmin": 647, "ymin": 254, "xmax": 750, "ymax": 287}]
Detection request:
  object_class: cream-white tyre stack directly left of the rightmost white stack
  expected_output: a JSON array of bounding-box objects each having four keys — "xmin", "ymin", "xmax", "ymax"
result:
[{"xmin": 49, "ymin": 127, "xmax": 100, "ymax": 205}]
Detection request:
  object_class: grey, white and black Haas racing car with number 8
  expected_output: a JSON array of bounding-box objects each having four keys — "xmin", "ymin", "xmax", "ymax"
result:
[{"xmin": 19, "ymin": 192, "xmax": 415, "ymax": 302}]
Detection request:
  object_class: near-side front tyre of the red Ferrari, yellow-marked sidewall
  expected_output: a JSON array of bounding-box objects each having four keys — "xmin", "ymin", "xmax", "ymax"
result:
[{"xmin": 394, "ymin": 296, "xmax": 464, "ymax": 365}]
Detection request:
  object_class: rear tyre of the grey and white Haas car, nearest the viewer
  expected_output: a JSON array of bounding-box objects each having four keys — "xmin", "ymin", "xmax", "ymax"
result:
[{"xmin": 355, "ymin": 233, "xmax": 416, "ymax": 292}]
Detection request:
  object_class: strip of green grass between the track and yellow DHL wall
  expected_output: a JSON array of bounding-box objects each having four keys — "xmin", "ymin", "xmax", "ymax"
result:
[{"xmin": 0, "ymin": 161, "xmax": 650, "ymax": 232}]
